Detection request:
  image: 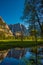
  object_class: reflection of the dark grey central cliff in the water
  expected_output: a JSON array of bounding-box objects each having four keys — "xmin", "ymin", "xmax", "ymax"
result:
[{"xmin": 7, "ymin": 48, "xmax": 25, "ymax": 59}]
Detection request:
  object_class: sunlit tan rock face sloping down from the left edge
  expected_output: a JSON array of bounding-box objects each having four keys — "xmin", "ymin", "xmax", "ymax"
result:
[{"xmin": 0, "ymin": 17, "xmax": 13, "ymax": 37}]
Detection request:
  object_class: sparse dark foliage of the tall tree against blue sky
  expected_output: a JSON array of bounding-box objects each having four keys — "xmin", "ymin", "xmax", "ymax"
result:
[{"xmin": 22, "ymin": 0, "xmax": 43, "ymax": 38}]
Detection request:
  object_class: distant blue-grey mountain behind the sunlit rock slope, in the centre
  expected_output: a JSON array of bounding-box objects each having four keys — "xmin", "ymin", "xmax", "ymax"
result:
[{"xmin": 9, "ymin": 23, "xmax": 27, "ymax": 35}]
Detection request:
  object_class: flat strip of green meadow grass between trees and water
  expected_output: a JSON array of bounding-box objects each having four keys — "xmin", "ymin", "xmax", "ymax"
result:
[{"xmin": 0, "ymin": 40, "xmax": 43, "ymax": 49}]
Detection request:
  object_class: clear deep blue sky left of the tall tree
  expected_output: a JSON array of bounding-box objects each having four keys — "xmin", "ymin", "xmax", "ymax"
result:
[{"xmin": 0, "ymin": 0, "xmax": 26, "ymax": 25}]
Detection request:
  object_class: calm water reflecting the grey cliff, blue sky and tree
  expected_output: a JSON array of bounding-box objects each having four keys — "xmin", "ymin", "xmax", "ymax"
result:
[{"xmin": 0, "ymin": 48, "xmax": 43, "ymax": 65}]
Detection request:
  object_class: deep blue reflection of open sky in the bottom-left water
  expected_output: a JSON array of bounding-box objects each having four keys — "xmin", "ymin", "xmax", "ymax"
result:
[{"xmin": 1, "ymin": 57, "xmax": 25, "ymax": 65}]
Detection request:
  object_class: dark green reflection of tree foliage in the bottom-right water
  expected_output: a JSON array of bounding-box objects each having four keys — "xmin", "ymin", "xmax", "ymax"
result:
[{"xmin": 21, "ymin": 51, "xmax": 41, "ymax": 65}]
